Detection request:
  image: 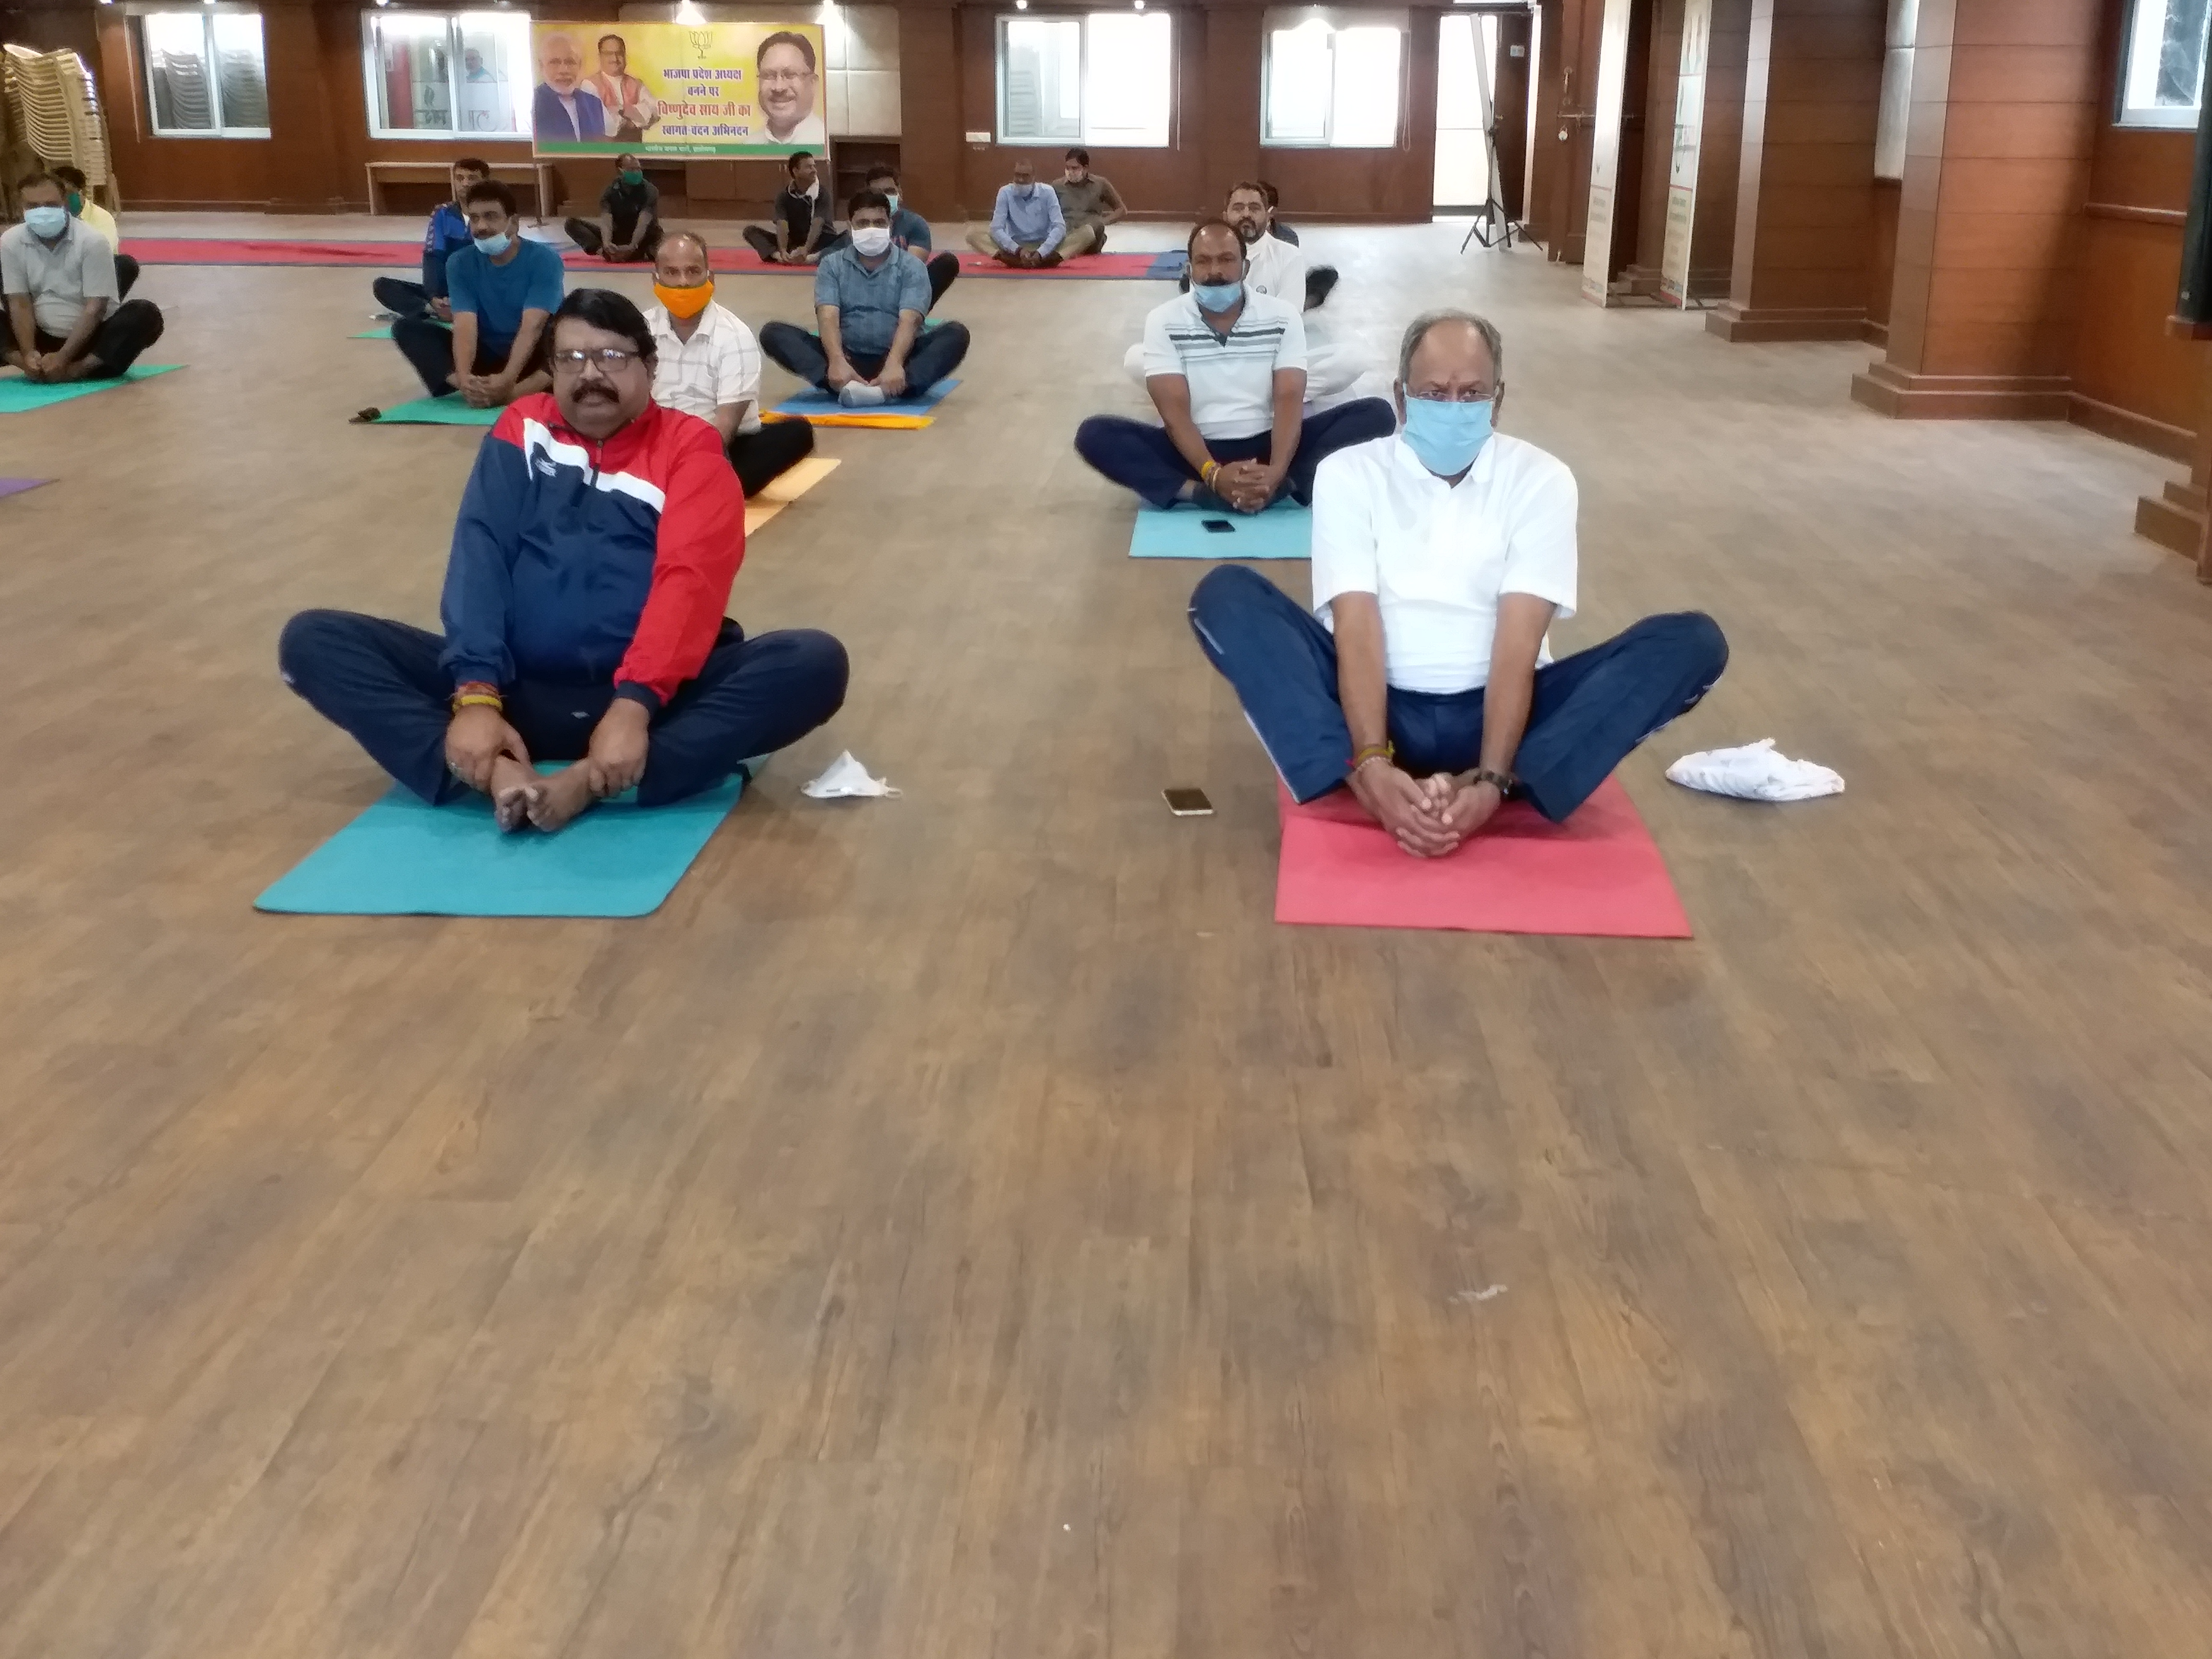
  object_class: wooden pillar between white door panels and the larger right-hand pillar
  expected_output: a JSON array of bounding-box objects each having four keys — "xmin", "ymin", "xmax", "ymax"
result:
[{"xmin": 1706, "ymin": 0, "xmax": 1875, "ymax": 341}]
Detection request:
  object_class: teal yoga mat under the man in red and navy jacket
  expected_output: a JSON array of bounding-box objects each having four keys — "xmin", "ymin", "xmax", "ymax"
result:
[{"xmin": 254, "ymin": 774, "xmax": 745, "ymax": 916}]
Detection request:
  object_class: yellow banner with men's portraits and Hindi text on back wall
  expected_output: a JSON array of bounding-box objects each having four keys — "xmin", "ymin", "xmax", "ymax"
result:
[{"xmin": 531, "ymin": 22, "xmax": 830, "ymax": 157}]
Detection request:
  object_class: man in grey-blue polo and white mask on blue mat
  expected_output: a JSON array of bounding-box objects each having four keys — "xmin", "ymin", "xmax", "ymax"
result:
[{"xmin": 761, "ymin": 190, "xmax": 969, "ymax": 407}]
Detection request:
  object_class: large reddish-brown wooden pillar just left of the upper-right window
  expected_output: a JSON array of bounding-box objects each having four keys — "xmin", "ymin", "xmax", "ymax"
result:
[{"xmin": 1851, "ymin": 0, "xmax": 2104, "ymax": 421}]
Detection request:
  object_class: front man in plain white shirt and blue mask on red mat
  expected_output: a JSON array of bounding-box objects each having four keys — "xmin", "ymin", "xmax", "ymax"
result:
[{"xmin": 1190, "ymin": 310, "xmax": 1728, "ymax": 858}]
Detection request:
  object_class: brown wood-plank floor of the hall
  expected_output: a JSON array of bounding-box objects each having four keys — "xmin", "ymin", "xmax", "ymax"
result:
[{"xmin": 0, "ymin": 221, "xmax": 2212, "ymax": 1659}]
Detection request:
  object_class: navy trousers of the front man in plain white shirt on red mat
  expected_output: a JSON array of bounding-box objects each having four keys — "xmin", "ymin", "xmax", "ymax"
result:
[{"xmin": 1190, "ymin": 564, "xmax": 1728, "ymax": 823}]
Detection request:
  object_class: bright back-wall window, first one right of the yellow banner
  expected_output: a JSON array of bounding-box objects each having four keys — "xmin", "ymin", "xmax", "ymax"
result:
[{"xmin": 998, "ymin": 11, "xmax": 1175, "ymax": 148}]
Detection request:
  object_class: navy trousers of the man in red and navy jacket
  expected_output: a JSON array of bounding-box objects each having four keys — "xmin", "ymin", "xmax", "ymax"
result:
[{"xmin": 276, "ymin": 611, "xmax": 847, "ymax": 807}]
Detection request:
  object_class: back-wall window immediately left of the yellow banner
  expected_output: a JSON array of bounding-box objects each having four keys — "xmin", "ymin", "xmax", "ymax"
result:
[{"xmin": 361, "ymin": 11, "xmax": 535, "ymax": 139}]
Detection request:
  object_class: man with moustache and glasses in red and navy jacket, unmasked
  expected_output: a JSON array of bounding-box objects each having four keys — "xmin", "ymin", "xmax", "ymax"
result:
[{"xmin": 276, "ymin": 288, "xmax": 847, "ymax": 830}]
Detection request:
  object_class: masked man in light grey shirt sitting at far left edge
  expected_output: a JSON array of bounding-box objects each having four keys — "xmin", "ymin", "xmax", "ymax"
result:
[{"xmin": 0, "ymin": 172, "xmax": 161, "ymax": 385}]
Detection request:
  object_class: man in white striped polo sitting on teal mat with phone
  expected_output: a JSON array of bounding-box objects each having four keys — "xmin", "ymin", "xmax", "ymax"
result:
[{"xmin": 1075, "ymin": 219, "xmax": 1396, "ymax": 513}]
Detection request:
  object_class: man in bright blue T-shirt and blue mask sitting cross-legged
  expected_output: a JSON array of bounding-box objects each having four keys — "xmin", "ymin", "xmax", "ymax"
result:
[{"xmin": 392, "ymin": 179, "xmax": 562, "ymax": 409}]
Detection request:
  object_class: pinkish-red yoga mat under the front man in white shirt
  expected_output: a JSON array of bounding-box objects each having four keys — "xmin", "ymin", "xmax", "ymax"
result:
[{"xmin": 1274, "ymin": 779, "xmax": 1690, "ymax": 938}]
